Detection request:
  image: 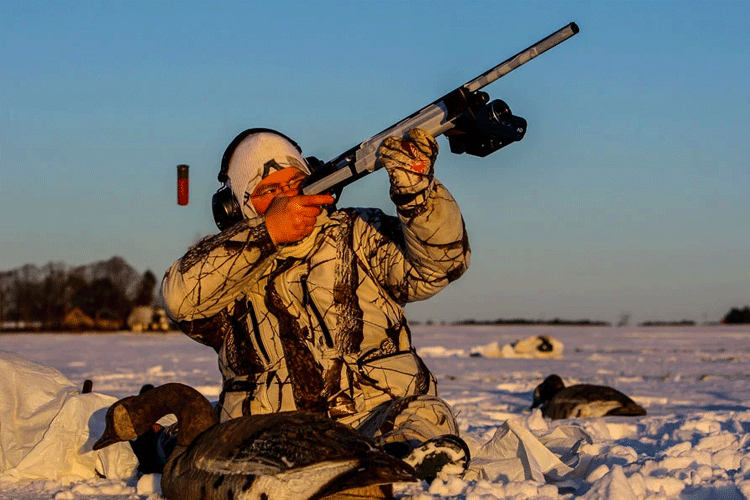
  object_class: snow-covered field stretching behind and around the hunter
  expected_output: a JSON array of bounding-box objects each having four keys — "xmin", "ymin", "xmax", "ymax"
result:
[{"xmin": 0, "ymin": 326, "xmax": 750, "ymax": 500}]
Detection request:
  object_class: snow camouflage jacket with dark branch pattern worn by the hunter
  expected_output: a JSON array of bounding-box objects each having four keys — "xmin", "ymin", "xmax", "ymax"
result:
[{"xmin": 162, "ymin": 178, "xmax": 470, "ymax": 423}]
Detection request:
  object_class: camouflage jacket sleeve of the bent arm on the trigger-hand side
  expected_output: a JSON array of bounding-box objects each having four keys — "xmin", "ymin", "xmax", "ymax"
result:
[{"xmin": 162, "ymin": 217, "xmax": 276, "ymax": 338}]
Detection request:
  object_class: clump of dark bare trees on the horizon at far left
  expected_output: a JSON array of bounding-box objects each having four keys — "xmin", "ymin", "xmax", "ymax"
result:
[{"xmin": 0, "ymin": 257, "xmax": 156, "ymax": 331}]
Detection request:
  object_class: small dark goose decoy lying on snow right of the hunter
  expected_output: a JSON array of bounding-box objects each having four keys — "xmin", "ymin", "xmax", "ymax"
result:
[{"xmin": 531, "ymin": 374, "xmax": 646, "ymax": 420}]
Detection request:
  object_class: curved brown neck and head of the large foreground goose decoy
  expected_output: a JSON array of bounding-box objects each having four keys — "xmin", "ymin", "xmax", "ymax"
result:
[{"xmin": 94, "ymin": 383, "xmax": 219, "ymax": 450}]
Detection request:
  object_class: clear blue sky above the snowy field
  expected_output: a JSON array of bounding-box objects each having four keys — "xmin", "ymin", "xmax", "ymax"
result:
[{"xmin": 0, "ymin": 0, "xmax": 750, "ymax": 321}]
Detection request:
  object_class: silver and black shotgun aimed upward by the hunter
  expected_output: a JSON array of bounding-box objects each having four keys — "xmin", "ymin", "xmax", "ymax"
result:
[{"xmin": 302, "ymin": 23, "xmax": 578, "ymax": 199}]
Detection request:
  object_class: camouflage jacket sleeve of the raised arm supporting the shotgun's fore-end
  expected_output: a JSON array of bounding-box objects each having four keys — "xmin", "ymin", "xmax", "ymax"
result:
[{"xmin": 355, "ymin": 179, "xmax": 471, "ymax": 303}]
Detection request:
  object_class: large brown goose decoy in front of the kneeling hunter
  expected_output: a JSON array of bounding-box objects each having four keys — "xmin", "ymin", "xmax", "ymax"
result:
[{"xmin": 94, "ymin": 383, "xmax": 416, "ymax": 500}]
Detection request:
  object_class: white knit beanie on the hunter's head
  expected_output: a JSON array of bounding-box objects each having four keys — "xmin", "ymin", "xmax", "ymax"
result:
[{"xmin": 227, "ymin": 132, "xmax": 310, "ymax": 219}]
